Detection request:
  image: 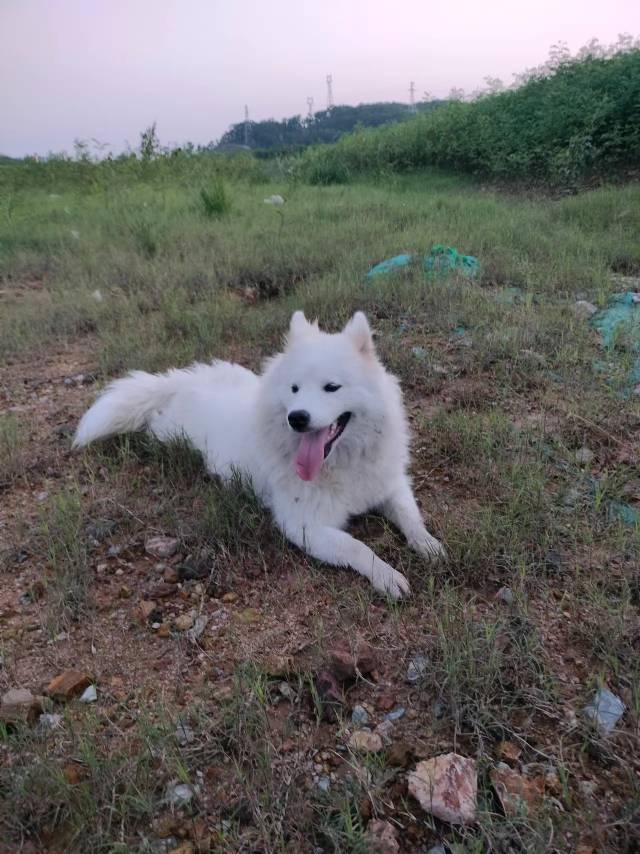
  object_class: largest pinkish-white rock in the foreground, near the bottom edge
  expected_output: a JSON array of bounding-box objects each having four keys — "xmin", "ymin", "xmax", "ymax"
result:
[{"xmin": 408, "ymin": 753, "xmax": 478, "ymax": 824}]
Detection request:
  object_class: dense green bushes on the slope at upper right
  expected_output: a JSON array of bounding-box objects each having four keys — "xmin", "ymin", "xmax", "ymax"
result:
[{"xmin": 298, "ymin": 50, "xmax": 640, "ymax": 186}]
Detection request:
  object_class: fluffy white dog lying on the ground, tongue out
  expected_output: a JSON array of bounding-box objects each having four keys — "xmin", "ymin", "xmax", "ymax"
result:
[{"xmin": 74, "ymin": 311, "xmax": 445, "ymax": 598}]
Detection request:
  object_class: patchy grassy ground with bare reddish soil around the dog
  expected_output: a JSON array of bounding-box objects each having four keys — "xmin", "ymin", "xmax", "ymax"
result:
[{"xmin": 0, "ymin": 158, "xmax": 640, "ymax": 852}]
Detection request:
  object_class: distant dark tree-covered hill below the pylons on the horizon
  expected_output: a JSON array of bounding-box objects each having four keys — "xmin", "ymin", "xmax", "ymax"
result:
[{"xmin": 218, "ymin": 101, "xmax": 445, "ymax": 149}]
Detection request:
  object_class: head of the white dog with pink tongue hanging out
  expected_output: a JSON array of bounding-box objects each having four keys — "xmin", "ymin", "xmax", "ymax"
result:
[{"xmin": 263, "ymin": 311, "xmax": 385, "ymax": 481}]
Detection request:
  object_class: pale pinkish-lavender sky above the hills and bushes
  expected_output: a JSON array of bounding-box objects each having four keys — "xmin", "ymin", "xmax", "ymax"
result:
[{"xmin": 0, "ymin": 0, "xmax": 640, "ymax": 156}]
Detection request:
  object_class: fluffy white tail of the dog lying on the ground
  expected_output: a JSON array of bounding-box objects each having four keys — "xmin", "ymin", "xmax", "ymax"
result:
[{"xmin": 73, "ymin": 371, "xmax": 179, "ymax": 448}]
